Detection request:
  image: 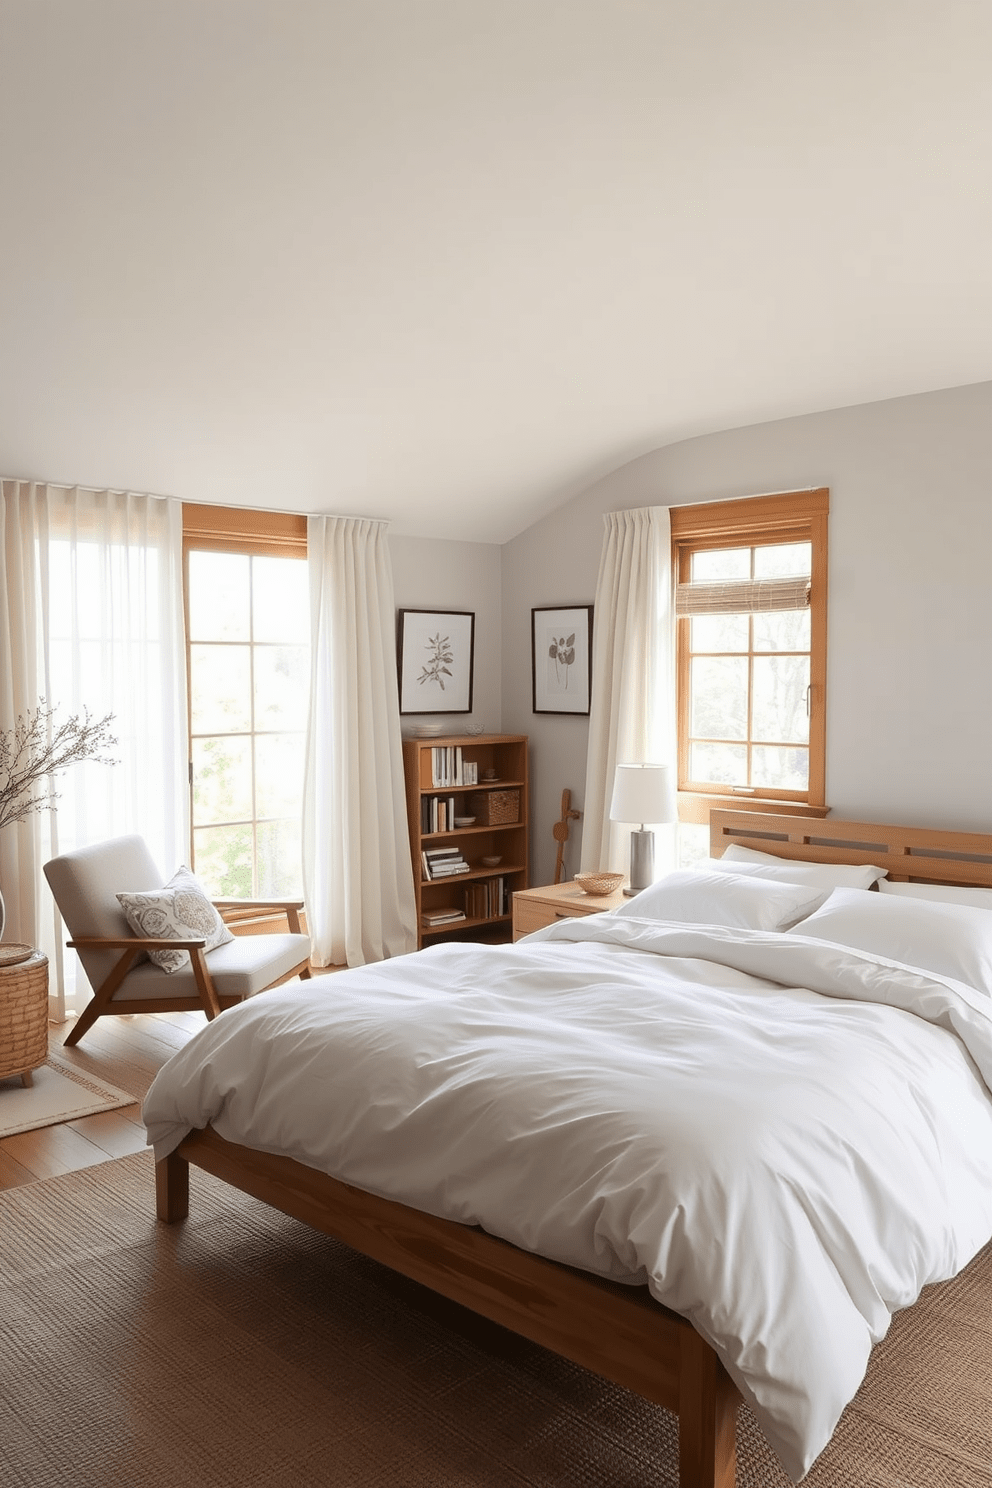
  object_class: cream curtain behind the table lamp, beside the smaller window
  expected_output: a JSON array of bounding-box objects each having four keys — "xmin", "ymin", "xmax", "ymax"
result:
[{"xmin": 582, "ymin": 506, "xmax": 675, "ymax": 872}]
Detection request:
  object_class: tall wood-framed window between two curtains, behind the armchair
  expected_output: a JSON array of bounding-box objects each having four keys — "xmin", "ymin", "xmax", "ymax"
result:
[{"xmin": 183, "ymin": 506, "xmax": 309, "ymax": 899}]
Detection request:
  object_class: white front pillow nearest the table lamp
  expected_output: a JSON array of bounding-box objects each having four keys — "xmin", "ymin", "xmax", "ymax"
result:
[{"xmin": 613, "ymin": 868, "xmax": 827, "ymax": 930}]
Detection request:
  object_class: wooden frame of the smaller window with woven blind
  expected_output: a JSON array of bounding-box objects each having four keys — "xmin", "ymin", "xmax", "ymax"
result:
[{"xmin": 671, "ymin": 487, "xmax": 830, "ymax": 821}]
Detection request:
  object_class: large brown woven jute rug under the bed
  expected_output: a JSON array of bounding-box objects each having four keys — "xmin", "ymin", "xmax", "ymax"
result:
[{"xmin": 0, "ymin": 1153, "xmax": 992, "ymax": 1488}]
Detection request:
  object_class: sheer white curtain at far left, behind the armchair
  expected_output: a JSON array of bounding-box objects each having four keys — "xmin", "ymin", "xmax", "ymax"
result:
[{"xmin": 0, "ymin": 481, "xmax": 189, "ymax": 1018}]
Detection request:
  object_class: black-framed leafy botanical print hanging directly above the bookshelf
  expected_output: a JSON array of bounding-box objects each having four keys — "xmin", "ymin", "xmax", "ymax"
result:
[{"xmin": 397, "ymin": 610, "xmax": 476, "ymax": 713}]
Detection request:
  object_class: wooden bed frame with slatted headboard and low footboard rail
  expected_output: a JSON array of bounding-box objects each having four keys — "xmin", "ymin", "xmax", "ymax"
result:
[{"xmin": 156, "ymin": 811, "xmax": 992, "ymax": 1488}]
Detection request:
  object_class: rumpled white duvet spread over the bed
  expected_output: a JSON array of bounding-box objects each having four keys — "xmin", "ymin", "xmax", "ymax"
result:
[{"xmin": 144, "ymin": 915, "xmax": 992, "ymax": 1479}]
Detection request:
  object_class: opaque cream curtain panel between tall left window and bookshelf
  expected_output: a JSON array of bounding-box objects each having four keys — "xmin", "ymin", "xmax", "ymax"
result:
[{"xmin": 303, "ymin": 516, "xmax": 416, "ymax": 966}]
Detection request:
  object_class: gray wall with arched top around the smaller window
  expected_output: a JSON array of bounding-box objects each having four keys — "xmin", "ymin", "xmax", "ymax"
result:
[{"xmin": 503, "ymin": 382, "xmax": 992, "ymax": 882}]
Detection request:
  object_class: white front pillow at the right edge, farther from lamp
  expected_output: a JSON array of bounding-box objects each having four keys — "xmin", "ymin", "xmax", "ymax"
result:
[{"xmin": 788, "ymin": 888, "xmax": 992, "ymax": 997}]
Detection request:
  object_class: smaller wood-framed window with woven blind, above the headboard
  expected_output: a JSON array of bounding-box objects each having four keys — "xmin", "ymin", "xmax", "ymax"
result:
[{"xmin": 672, "ymin": 491, "xmax": 828, "ymax": 821}]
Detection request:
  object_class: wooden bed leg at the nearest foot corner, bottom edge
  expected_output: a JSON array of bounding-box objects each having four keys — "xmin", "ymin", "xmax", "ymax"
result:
[{"xmin": 678, "ymin": 1327, "xmax": 741, "ymax": 1488}]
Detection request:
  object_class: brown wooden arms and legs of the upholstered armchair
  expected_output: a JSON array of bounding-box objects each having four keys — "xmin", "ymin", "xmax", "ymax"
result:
[{"xmin": 64, "ymin": 899, "xmax": 311, "ymax": 1048}]
